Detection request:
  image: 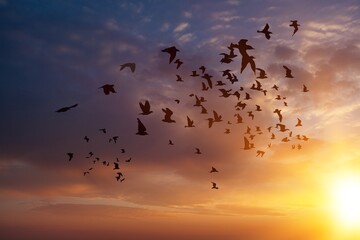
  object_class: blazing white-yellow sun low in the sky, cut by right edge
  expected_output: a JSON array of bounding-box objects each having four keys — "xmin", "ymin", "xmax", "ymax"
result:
[{"xmin": 332, "ymin": 175, "xmax": 360, "ymax": 228}]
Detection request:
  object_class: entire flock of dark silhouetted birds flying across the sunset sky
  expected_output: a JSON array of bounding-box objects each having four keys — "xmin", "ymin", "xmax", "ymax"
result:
[{"xmin": 56, "ymin": 20, "xmax": 309, "ymax": 189}]
